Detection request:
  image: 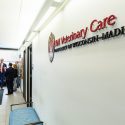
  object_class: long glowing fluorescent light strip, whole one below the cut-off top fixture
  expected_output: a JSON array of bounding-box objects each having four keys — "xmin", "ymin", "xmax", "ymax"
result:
[{"xmin": 34, "ymin": 6, "xmax": 56, "ymax": 31}]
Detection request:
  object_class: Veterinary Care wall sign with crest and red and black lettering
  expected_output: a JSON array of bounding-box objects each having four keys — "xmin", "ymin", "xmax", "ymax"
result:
[{"xmin": 48, "ymin": 15, "xmax": 125, "ymax": 62}]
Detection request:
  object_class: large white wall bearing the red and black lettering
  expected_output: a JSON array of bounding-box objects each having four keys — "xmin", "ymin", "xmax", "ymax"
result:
[{"xmin": 33, "ymin": 0, "xmax": 125, "ymax": 125}]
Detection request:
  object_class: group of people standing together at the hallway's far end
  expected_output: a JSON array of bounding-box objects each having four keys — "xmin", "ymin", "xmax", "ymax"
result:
[{"xmin": 0, "ymin": 59, "xmax": 20, "ymax": 95}]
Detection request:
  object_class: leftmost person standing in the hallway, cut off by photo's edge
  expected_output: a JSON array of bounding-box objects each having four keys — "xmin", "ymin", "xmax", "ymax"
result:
[{"xmin": 0, "ymin": 58, "xmax": 7, "ymax": 89}]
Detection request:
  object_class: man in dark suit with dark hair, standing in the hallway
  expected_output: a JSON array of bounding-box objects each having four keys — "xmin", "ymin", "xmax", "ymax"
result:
[{"xmin": 5, "ymin": 63, "xmax": 14, "ymax": 95}]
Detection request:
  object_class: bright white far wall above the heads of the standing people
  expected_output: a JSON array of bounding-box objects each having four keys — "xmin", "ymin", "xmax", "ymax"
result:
[{"xmin": 0, "ymin": 49, "xmax": 19, "ymax": 64}]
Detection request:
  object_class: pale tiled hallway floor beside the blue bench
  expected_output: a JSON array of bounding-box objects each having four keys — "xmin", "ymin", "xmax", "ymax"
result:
[{"xmin": 0, "ymin": 87, "xmax": 24, "ymax": 125}]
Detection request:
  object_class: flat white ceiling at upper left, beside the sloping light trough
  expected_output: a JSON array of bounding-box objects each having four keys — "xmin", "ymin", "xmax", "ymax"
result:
[{"xmin": 0, "ymin": 0, "xmax": 45, "ymax": 48}]
